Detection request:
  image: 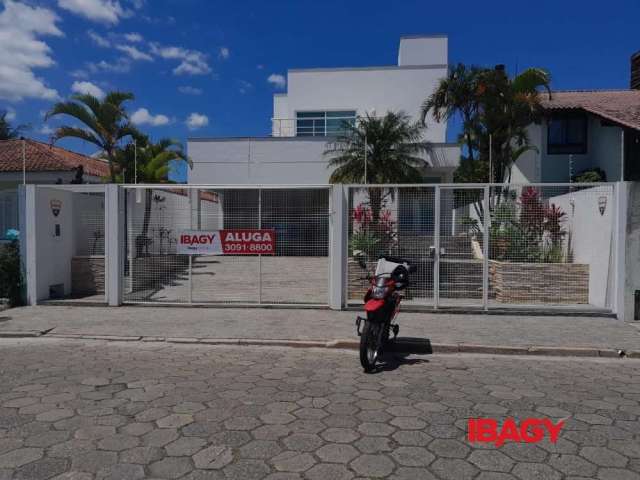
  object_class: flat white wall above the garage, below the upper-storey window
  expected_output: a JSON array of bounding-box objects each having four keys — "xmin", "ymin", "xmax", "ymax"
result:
[{"xmin": 187, "ymin": 137, "xmax": 460, "ymax": 185}]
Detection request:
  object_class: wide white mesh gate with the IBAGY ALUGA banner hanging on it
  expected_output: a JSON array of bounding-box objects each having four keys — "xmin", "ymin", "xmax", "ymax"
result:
[{"xmin": 123, "ymin": 185, "xmax": 330, "ymax": 305}]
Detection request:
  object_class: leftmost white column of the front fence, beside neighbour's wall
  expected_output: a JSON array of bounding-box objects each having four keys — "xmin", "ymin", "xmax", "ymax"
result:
[{"xmin": 18, "ymin": 185, "xmax": 38, "ymax": 305}]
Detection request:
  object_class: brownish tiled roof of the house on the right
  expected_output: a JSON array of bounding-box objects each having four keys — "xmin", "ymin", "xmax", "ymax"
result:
[{"xmin": 542, "ymin": 90, "xmax": 640, "ymax": 130}]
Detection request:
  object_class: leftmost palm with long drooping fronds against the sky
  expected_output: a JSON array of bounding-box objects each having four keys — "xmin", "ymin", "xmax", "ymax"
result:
[{"xmin": 45, "ymin": 92, "xmax": 139, "ymax": 183}]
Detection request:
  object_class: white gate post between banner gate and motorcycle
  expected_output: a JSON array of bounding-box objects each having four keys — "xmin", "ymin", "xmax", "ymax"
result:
[{"xmin": 329, "ymin": 185, "xmax": 348, "ymax": 310}]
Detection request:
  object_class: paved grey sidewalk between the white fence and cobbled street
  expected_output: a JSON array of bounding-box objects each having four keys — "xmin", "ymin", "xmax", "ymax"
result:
[{"xmin": 0, "ymin": 306, "xmax": 640, "ymax": 358}]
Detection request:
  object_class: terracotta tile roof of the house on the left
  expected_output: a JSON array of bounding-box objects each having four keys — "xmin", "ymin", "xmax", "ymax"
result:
[{"xmin": 0, "ymin": 139, "xmax": 109, "ymax": 177}]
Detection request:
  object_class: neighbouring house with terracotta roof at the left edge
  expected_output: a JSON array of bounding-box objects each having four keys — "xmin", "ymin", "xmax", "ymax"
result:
[{"xmin": 0, "ymin": 139, "xmax": 109, "ymax": 241}]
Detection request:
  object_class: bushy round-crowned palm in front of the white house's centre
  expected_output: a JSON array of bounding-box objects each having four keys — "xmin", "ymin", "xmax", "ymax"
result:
[{"xmin": 324, "ymin": 112, "xmax": 429, "ymax": 228}]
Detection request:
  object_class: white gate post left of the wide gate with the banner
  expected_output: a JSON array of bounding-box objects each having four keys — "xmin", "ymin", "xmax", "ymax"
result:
[{"xmin": 104, "ymin": 184, "xmax": 125, "ymax": 307}]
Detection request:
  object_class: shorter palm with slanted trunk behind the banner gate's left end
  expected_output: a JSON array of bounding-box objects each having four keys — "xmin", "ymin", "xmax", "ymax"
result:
[{"xmin": 116, "ymin": 134, "xmax": 193, "ymax": 256}]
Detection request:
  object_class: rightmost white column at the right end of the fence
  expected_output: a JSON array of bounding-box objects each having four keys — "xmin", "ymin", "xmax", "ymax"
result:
[{"xmin": 613, "ymin": 182, "xmax": 633, "ymax": 320}]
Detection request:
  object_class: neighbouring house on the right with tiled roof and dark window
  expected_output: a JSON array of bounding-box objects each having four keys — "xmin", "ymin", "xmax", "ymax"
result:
[{"xmin": 511, "ymin": 52, "xmax": 640, "ymax": 183}]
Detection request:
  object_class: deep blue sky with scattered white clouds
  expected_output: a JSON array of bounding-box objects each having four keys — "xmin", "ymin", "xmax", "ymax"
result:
[{"xmin": 0, "ymin": 0, "xmax": 640, "ymax": 180}]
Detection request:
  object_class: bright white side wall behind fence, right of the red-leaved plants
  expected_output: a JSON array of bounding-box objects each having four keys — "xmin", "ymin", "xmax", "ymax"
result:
[{"xmin": 549, "ymin": 186, "xmax": 615, "ymax": 307}]
